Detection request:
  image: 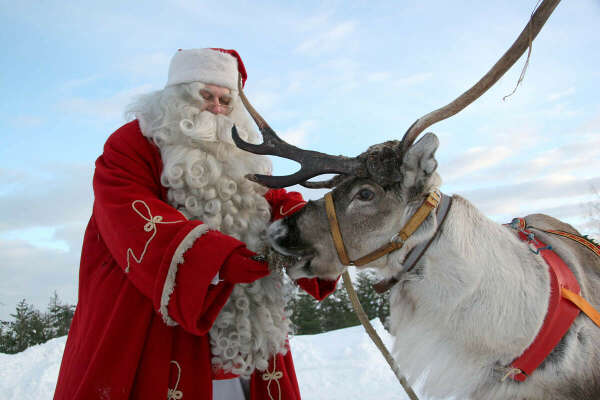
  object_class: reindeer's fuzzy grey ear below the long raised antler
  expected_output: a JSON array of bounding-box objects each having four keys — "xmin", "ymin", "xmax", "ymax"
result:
[{"xmin": 402, "ymin": 132, "xmax": 440, "ymax": 188}]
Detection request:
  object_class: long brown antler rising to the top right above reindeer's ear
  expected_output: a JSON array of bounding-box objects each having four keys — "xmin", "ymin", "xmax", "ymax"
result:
[{"xmin": 402, "ymin": 0, "xmax": 560, "ymax": 151}]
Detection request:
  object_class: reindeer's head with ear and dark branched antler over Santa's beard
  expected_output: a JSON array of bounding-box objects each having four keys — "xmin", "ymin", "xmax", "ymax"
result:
[{"xmin": 232, "ymin": 76, "xmax": 440, "ymax": 279}]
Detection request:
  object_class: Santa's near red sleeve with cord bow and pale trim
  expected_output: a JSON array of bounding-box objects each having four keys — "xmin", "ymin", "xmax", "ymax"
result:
[{"xmin": 93, "ymin": 122, "xmax": 244, "ymax": 335}]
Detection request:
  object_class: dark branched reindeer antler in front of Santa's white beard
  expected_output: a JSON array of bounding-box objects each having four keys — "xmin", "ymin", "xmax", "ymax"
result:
[{"xmin": 231, "ymin": 75, "xmax": 367, "ymax": 188}]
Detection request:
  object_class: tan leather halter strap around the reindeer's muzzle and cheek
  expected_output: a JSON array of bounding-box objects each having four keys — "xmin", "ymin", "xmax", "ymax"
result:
[{"xmin": 325, "ymin": 192, "xmax": 440, "ymax": 266}]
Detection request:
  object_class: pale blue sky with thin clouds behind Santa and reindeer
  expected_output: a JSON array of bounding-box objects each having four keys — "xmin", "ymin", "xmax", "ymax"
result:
[{"xmin": 0, "ymin": 0, "xmax": 600, "ymax": 319}]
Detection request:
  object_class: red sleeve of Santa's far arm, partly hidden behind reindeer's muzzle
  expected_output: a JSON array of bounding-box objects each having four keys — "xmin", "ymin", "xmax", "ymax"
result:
[{"xmin": 265, "ymin": 189, "xmax": 339, "ymax": 300}]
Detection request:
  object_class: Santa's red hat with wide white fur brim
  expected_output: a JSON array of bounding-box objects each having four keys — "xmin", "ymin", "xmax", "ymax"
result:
[{"xmin": 165, "ymin": 48, "xmax": 247, "ymax": 90}]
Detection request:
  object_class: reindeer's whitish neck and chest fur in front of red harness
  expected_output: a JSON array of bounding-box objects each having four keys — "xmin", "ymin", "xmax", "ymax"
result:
[{"xmin": 390, "ymin": 196, "xmax": 549, "ymax": 399}]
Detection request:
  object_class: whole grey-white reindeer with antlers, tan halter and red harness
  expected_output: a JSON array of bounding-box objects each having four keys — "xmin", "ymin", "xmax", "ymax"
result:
[{"xmin": 232, "ymin": 0, "xmax": 600, "ymax": 400}]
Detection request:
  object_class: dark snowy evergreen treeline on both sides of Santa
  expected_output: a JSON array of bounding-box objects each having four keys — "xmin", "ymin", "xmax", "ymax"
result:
[{"xmin": 0, "ymin": 272, "xmax": 390, "ymax": 354}]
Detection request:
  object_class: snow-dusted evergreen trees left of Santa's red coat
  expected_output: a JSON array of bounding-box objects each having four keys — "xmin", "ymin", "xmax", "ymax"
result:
[{"xmin": 0, "ymin": 292, "xmax": 75, "ymax": 354}]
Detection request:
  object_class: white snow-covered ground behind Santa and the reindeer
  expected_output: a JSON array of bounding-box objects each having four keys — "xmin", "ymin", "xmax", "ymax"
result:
[{"xmin": 0, "ymin": 320, "xmax": 424, "ymax": 400}]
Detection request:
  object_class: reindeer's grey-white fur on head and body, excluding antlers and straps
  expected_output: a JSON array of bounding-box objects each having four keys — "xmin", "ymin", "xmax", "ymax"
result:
[{"xmin": 269, "ymin": 133, "xmax": 600, "ymax": 400}]
